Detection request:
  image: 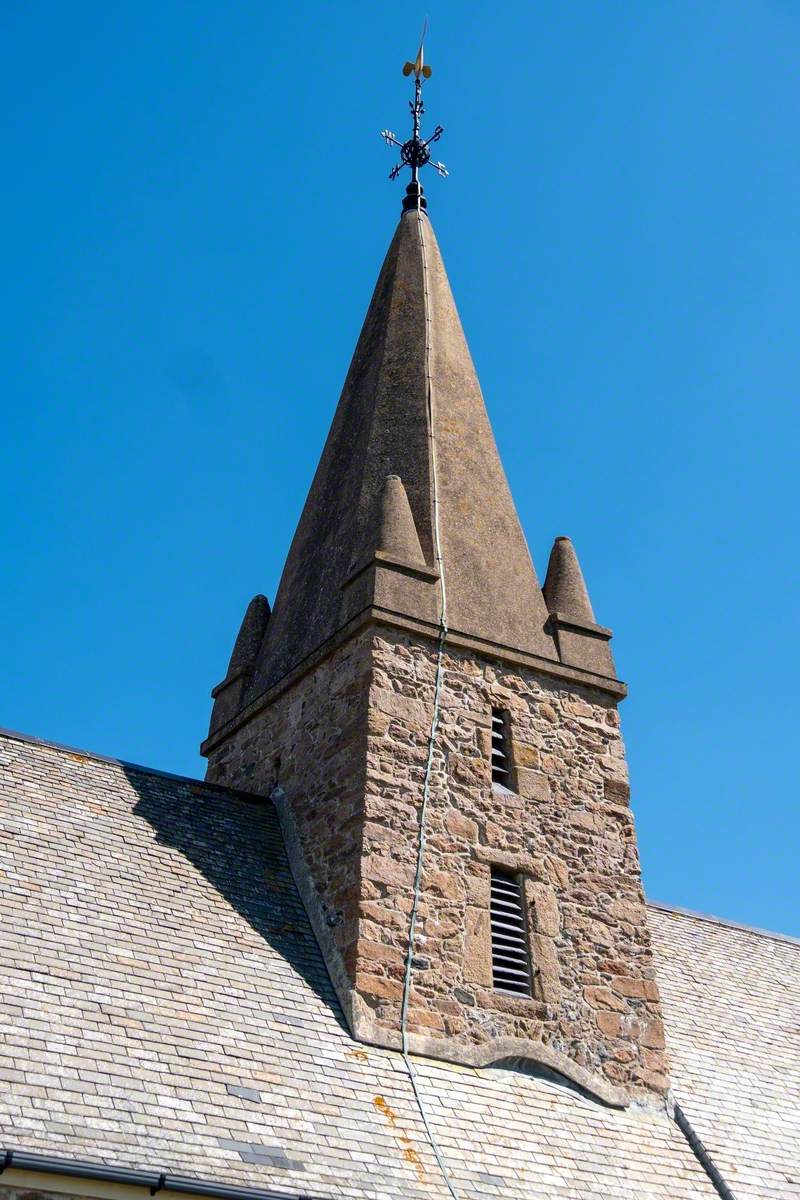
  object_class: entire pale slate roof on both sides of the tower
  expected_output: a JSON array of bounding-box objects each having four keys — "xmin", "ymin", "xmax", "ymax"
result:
[{"xmin": 0, "ymin": 734, "xmax": 800, "ymax": 1200}]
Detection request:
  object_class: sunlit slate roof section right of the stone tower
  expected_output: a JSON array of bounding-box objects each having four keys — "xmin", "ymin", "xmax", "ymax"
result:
[{"xmin": 650, "ymin": 906, "xmax": 800, "ymax": 1200}]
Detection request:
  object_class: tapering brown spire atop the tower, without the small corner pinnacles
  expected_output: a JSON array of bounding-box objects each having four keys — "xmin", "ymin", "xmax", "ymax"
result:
[{"xmin": 248, "ymin": 211, "xmax": 558, "ymax": 698}]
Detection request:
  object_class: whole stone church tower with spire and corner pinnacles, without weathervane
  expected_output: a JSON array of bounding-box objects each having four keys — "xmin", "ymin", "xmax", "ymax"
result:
[{"xmin": 203, "ymin": 206, "xmax": 668, "ymax": 1104}]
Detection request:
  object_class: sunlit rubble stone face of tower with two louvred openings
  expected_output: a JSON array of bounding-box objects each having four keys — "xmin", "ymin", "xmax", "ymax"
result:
[{"xmin": 357, "ymin": 634, "xmax": 667, "ymax": 1091}]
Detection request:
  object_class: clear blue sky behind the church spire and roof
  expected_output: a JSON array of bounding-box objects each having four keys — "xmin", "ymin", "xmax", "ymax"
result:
[{"xmin": 0, "ymin": 0, "xmax": 800, "ymax": 934}]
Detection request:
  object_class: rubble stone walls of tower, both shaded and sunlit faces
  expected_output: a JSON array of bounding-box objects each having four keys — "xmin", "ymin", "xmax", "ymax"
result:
[{"xmin": 207, "ymin": 629, "xmax": 668, "ymax": 1096}]
